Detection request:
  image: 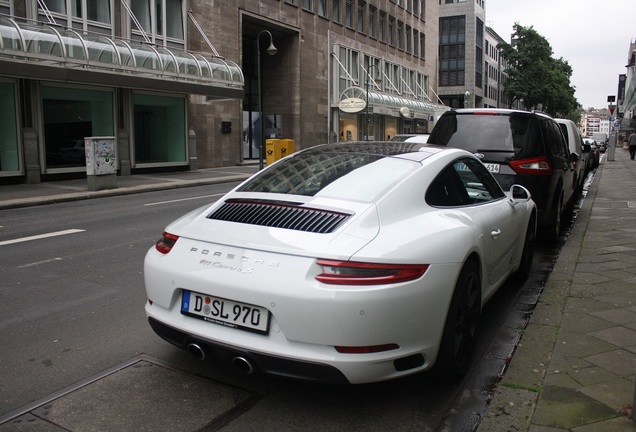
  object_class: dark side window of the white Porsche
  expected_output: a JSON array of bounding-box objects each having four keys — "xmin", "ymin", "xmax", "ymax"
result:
[{"xmin": 425, "ymin": 158, "xmax": 505, "ymax": 207}]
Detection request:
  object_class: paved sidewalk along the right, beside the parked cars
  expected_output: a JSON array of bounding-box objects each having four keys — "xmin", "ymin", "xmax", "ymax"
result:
[{"xmin": 478, "ymin": 148, "xmax": 636, "ymax": 432}]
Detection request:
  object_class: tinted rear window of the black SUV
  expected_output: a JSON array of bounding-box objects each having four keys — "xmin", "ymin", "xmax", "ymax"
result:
[{"xmin": 428, "ymin": 113, "xmax": 544, "ymax": 159}]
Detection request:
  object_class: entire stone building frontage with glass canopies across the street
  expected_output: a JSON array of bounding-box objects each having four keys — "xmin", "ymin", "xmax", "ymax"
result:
[{"xmin": 0, "ymin": 0, "xmax": 448, "ymax": 183}]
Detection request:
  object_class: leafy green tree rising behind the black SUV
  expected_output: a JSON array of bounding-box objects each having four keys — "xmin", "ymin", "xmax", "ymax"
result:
[{"xmin": 497, "ymin": 24, "xmax": 579, "ymax": 117}]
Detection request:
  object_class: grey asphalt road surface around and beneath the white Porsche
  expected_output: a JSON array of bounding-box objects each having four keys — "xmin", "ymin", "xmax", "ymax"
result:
[{"xmin": 0, "ymin": 184, "xmax": 558, "ymax": 431}]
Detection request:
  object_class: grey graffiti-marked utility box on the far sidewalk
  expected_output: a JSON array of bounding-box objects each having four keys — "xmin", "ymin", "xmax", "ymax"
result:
[{"xmin": 84, "ymin": 136, "xmax": 117, "ymax": 190}]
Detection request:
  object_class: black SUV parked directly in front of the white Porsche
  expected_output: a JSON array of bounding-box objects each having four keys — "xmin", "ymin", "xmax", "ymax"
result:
[{"xmin": 428, "ymin": 108, "xmax": 577, "ymax": 241}]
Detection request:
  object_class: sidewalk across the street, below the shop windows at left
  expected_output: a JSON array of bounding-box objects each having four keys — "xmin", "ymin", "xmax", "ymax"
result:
[{"xmin": 0, "ymin": 164, "xmax": 258, "ymax": 210}]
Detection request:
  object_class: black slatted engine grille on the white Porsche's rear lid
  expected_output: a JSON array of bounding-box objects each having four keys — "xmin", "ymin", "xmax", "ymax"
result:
[{"xmin": 208, "ymin": 200, "xmax": 352, "ymax": 234}]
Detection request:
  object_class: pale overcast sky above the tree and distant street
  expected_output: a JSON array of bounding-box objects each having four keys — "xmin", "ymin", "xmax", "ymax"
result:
[{"xmin": 486, "ymin": 0, "xmax": 636, "ymax": 109}]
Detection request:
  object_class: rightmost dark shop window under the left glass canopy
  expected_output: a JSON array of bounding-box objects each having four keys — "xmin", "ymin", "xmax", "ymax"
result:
[{"xmin": 133, "ymin": 93, "xmax": 187, "ymax": 166}]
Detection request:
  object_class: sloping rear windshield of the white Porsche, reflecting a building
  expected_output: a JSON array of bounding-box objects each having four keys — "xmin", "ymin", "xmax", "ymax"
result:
[{"xmin": 238, "ymin": 152, "xmax": 420, "ymax": 202}]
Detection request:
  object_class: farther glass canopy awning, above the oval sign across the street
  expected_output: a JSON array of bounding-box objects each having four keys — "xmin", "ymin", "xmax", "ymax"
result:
[{"xmin": 340, "ymin": 86, "xmax": 450, "ymax": 120}]
